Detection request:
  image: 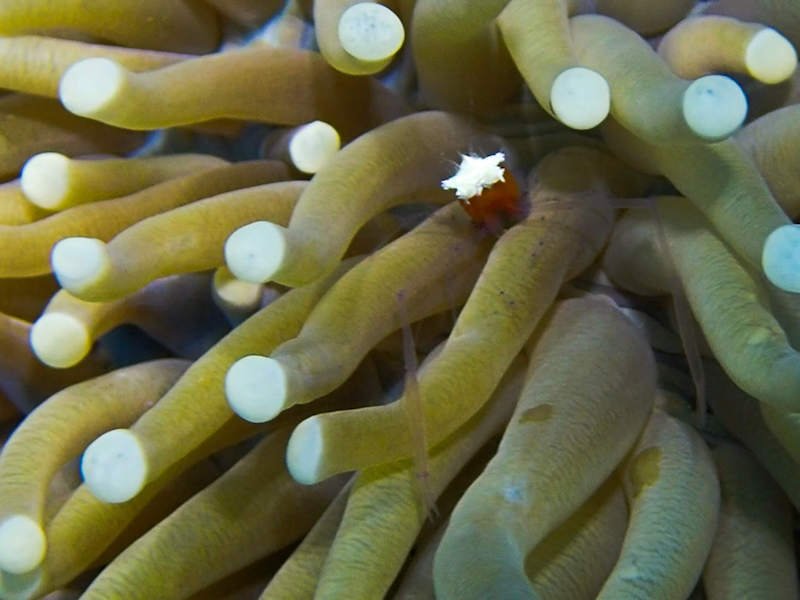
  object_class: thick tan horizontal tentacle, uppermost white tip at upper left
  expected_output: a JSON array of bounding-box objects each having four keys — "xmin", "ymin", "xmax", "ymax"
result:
[{"xmin": 59, "ymin": 46, "xmax": 407, "ymax": 139}]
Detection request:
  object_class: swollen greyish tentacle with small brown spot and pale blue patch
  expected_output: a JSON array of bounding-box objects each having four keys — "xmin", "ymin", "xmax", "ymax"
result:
[{"xmin": 434, "ymin": 300, "xmax": 655, "ymax": 598}]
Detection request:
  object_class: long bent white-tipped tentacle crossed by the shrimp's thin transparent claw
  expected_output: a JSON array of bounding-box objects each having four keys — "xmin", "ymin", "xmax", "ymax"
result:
[{"xmin": 289, "ymin": 149, "xmax": 638, "ymax": 482}]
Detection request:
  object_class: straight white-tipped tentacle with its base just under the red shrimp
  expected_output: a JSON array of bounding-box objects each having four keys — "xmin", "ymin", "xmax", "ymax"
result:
[{"xmin": 225, "ymin": 204, "xmax": 487, "ymax": 422}]
